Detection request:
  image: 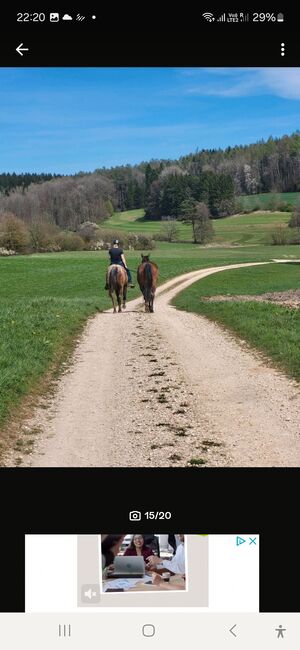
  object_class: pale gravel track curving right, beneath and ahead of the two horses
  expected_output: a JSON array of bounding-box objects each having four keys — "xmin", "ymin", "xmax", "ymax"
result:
[{"xmin": 8, "ymin": 264, "xmax": 300, "ymax": 467}]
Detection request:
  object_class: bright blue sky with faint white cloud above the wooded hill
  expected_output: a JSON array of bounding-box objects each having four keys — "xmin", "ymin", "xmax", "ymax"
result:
[{"xmin": 0, "ymin": 68, "xmax": 300, "ymax": 174}]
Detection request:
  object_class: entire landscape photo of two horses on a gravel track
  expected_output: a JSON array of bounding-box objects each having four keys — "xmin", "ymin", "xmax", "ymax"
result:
[{"xmin": 0, "ymin": 67, "xmax": 300, "ymax": 471}]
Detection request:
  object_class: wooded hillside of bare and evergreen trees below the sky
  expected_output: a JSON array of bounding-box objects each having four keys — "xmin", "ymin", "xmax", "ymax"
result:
[{"xmin": 0, "ymin": 131, "xmax": 300, "ymax": 231}]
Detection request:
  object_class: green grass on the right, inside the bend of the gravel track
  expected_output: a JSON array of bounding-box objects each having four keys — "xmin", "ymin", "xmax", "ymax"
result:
[{"xmin": 173, "ymin": 264, "xmax": 300, "ymax": 380}]
